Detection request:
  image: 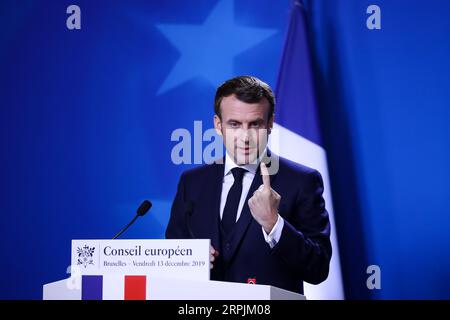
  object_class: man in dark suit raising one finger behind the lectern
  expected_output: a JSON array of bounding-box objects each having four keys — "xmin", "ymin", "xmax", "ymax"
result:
[{"xmin": 166, "ymin": 76, "xmax": 331, "ymax": 293}]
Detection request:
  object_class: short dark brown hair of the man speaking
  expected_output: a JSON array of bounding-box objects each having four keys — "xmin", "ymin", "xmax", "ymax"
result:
[{"xmin": 214, "ymin": 76, "xmax": 275, "ymax": 118}]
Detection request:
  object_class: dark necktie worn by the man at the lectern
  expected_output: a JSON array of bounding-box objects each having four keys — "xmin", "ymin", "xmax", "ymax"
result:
[{"xmin": 221, "ymin": 167, "xmax": 247, "ymax": 235}]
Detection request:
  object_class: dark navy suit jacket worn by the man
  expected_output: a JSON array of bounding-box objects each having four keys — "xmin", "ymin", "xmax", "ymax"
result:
[{"xmin": 166, "ymin": 157, "xmax": 331, "ymax": 293}]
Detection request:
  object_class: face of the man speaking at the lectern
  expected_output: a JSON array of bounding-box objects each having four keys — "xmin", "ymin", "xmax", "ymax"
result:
[{"xmin": 214, "ymin": 94, "xmax": 273, "ymax": 165}]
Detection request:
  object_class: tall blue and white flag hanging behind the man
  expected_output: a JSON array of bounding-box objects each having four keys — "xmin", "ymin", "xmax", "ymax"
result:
[{"xmin": 271, "ymin": 1, "xmax": 344, "ymax": 299}]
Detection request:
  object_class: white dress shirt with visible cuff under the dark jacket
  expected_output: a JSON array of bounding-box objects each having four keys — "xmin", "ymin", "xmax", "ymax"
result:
[{"xmin": 220, "ymin": 152, "xmax": 284, "ymax": 248}]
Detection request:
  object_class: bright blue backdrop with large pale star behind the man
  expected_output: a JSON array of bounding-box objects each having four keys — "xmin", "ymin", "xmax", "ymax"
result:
[{"xmin": 0, "ymin": 0, "xmax": 450, "ymax": 299}]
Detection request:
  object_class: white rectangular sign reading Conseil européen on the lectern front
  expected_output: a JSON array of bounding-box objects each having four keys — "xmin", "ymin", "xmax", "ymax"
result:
[{"xmin": 72, "ymin": 239, "xmax": 210, "ymax": 280}]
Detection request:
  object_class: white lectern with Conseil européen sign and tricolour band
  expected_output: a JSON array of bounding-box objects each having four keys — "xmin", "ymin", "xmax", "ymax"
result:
[{"xmin": 43, "ymin": 239, "xmax": 305, "ymax": 300}]
